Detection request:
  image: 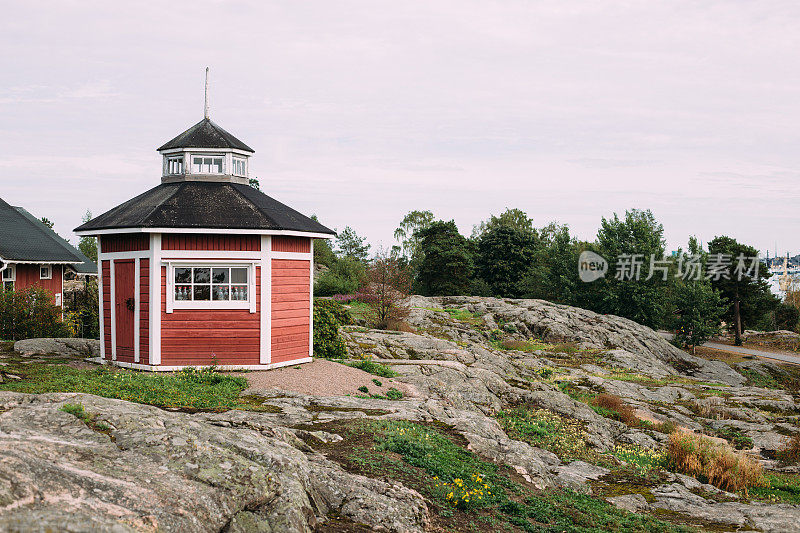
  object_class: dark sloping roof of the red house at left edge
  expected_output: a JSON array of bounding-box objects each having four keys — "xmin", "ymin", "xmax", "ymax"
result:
[{"xmin": 0, "ymin": 198, "xmax": 97, "ymax": 274}]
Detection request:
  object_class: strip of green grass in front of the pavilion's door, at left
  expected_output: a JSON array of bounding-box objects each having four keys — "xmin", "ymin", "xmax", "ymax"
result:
[{"xmin": 0, "ymin": 364, "xmax": 250, "ymax": 411}]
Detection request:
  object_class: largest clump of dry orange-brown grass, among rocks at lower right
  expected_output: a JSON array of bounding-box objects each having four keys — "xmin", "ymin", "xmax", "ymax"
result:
[{"xmin": 667, "ymin": 431, "xmax": 765, "ymax": 495}]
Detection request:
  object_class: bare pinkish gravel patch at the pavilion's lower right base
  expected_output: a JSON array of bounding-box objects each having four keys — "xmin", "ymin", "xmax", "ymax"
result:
[{"xmin": 236, "ymin": 359, "xmax": 416, "ymax": 396}]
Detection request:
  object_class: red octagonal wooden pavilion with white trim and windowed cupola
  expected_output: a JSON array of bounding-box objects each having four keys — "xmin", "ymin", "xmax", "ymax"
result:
[{"xmin": 75, "ymin": 118, "xmax": 334, "ymax": 370}]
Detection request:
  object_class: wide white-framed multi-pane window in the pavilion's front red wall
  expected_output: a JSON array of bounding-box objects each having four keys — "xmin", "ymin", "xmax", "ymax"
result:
[{"xmin": 175, "ymin": 266, "xmax": 249, "ymax": 302}]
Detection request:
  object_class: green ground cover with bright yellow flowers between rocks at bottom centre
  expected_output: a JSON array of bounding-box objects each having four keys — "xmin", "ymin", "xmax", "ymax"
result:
[{"xmin": 328, "ymin": 420, "xmax": 689, "ymax": 533}]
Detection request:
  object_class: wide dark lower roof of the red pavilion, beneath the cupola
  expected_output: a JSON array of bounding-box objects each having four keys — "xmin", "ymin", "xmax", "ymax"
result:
[{"xmin": 75, "ymin": 181, "xmax": 335, "ymax": 235}]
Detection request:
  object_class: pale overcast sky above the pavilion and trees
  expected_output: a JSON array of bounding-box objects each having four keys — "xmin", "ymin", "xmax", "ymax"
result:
[{"xmin": 0, "ymin": 0, "xmax": 800, "ymax": 255}]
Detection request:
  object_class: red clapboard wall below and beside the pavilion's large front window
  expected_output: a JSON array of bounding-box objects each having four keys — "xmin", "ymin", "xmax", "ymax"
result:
[{"xmin": 161, "ymin": 267, "xmax": 261, "ymax": 366}]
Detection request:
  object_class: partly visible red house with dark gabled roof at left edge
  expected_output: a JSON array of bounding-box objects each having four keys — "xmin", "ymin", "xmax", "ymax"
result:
[{"xmin": 0, "ymin": 199, "xmax": 97, "ymax": 306}]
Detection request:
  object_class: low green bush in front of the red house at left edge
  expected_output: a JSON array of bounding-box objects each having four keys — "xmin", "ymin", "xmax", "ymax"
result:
[{"xmin": 0, "ymin": 287, "xmax": 72, "ymax": 340}]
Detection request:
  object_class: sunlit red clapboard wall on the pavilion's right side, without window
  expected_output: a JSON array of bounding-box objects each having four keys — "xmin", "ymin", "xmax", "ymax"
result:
[{"xmin": 271, "ymin": 258, "xmax": 311, "ymax": 363}]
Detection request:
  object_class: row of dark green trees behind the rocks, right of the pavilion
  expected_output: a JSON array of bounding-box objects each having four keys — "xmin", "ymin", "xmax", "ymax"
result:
[{"xmin": 314, "ymin": 209, "xmax": 798, "ymax": 345}]
